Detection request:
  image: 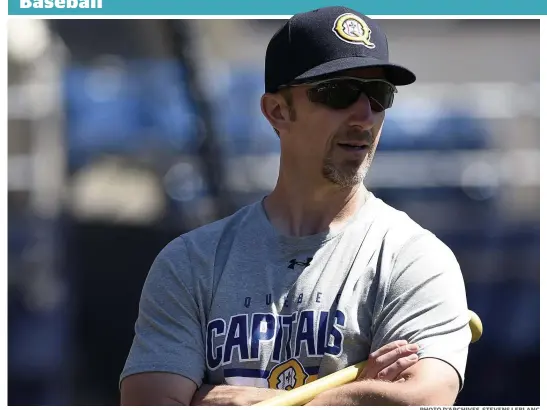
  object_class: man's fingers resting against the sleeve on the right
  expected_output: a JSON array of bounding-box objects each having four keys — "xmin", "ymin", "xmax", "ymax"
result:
[{"xmin": 359, "ymin": 340, "xmax": 419, "ymax": 381}]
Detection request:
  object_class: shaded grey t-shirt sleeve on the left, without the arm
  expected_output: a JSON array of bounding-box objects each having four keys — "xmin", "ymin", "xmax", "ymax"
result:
[{"xmin": 120, "ymin": 237, "xmax": 205, "ymax": 387}]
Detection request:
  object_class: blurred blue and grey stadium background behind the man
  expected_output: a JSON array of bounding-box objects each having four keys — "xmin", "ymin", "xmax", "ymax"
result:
[{"xmin": 8, "ymin": 19, "xmax": 540, "ymax": 405}]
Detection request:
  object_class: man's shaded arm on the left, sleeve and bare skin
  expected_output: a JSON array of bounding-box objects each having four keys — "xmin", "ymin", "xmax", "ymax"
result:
[{"xmin": 120, "ymin": 238, "xmax": 205, "ymax": 406}]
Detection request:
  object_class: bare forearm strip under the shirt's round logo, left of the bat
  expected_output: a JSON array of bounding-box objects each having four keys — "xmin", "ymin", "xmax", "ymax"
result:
[{"xmin": 191, "ymin": 384, "xmax": 285, "ymax": 406}]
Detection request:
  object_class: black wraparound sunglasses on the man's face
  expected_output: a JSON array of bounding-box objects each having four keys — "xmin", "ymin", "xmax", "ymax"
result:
[{"xmin": 295, "ymin": 77, "xmax": 397, "ymax": 112}]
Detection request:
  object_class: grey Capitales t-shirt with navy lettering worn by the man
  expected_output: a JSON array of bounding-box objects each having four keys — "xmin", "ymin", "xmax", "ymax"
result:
[{"xmin": 121, "ymin": 194, "xmax": 471, "ymax": 389}]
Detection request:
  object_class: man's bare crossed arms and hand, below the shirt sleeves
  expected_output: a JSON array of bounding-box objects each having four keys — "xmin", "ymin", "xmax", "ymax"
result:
[{"xmin": 121, "ymin": 341, "xmax": 459, "ymax": 406}]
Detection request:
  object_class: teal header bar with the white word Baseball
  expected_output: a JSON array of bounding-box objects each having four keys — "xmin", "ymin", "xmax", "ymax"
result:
[{"xmin": 8, "ymin": 0, "xmax": 547, "ymax": 16}]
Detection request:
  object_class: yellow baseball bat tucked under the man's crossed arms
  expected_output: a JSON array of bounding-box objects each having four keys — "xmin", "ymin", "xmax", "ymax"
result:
[{"xmin": 255, "ymin": 311, "xmax": 482, "ymax": 406}]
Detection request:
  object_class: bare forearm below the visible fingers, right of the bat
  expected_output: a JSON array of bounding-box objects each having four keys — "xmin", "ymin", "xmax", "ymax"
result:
[{"xmin": 307, "ymin": 380, "xmax": 420, "ymax": 406}]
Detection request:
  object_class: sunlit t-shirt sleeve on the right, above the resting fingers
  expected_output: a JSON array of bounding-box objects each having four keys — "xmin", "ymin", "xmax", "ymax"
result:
[{"xmin": 371, "ymin": 233, "xmax": 471, "ymax": 389}]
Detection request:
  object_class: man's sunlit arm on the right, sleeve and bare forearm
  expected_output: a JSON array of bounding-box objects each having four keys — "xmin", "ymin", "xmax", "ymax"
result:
[{"xmin": 309, "ymin": 234, "xmax": 471, "ymax": 406}]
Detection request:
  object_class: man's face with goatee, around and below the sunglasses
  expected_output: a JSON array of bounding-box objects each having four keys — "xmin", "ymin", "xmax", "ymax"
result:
[{"xmin": 281, "ymin": 69, "xmax": 385, "ymax": 188}]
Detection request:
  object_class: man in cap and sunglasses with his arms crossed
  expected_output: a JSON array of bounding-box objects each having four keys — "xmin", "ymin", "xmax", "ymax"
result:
[{"xmin": 121, "ymin": 7, "xmax": 471, "ymax": 405}]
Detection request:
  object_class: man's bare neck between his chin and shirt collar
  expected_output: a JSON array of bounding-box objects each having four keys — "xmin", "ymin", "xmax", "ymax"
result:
[{"xmin": 264, "ymin": 176, "xmax": 368, "ymax": 236}]
